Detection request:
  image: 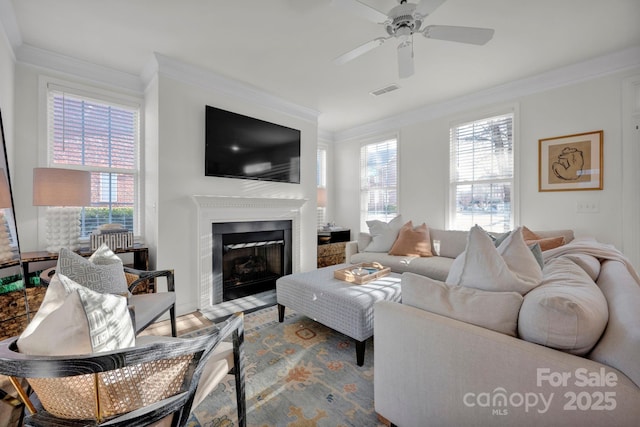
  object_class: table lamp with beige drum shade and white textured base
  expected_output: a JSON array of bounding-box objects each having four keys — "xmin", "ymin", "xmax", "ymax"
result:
[{"xmin": 33, "ymin": 168, "xmax": 91, "ymax": 252}]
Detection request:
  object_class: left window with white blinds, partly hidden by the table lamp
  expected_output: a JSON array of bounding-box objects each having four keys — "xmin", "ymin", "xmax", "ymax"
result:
[{"xmin": 47, "ymin": 83, "xmax": 140, "ymax": 237}]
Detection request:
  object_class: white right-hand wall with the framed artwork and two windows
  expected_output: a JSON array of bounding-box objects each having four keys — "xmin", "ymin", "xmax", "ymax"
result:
[{"xmin": 334, "ymin": 68, "xmax": 640, "ymax": 252}]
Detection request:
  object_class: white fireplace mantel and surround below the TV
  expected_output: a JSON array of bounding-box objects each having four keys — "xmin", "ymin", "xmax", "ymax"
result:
[{"xmin": 192, "ymin": 195, "xmax": 308, "ymax": 310}]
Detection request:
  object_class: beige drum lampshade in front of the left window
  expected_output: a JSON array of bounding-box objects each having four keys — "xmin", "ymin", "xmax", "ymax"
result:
[{"xmin": 33, "ymin": 168, "xmax": 91, "ymax": 206}]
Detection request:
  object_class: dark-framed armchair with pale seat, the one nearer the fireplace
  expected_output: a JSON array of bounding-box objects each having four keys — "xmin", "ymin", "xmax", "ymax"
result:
[{"xmin": 40, "ymin": 266, "xmax": 177, "ymax": 337}]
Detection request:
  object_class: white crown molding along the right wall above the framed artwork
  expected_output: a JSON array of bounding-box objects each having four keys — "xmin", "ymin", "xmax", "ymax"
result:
[{"xmin": 332, "ymin": 46, "xmax": 640, "ymax": 142}]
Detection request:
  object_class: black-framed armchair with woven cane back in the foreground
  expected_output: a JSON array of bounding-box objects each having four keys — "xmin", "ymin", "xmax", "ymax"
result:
[{"xmin": 0, "ymin": 313, "xmax": 246, "ymax": 427}]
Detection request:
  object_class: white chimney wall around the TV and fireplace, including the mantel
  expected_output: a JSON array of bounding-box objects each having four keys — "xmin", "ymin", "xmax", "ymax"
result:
[{"xmin": 147, "ymin": 72, "xmax": 317, "ymax": 312}]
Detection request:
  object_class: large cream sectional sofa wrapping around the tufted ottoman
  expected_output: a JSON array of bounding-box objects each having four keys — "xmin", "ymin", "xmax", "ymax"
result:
[{"xmin": 347, "ymin": 229, "xmax": 640, "ymax": 427}]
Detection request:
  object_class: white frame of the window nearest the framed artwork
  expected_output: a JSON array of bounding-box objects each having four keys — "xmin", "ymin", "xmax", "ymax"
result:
[{"xmin": 445, "ymin": 108, "xmax": 520, "ymax": 234}]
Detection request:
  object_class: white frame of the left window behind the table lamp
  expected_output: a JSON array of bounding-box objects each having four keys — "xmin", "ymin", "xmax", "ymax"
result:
[{"xmin": 38, "ymin": 75, "xmax": 145, "ymax": 241}]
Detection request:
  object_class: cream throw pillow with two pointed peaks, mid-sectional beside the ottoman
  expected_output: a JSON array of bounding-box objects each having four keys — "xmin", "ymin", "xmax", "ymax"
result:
[{"xmin": 446, "ymin": 225, "xmax": 542, "ymax": 295}]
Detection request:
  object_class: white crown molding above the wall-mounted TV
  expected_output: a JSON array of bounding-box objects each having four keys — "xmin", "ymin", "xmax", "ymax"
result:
[{"xmin": 142, "ymin": 53, "xmax": 319, "ymax": 124}]
